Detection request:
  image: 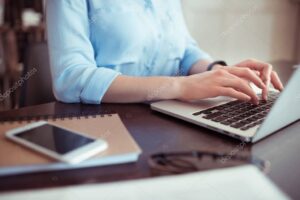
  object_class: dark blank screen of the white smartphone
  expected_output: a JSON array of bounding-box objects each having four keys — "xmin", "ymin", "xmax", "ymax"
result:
[{"xmin": 15, "ymin": 124, "xmax": 95, "ymax": 154}]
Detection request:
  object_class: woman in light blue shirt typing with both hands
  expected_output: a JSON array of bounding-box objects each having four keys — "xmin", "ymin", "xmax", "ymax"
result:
[{"xmin": 47, "ymin": 0, "xmax": 283, "ymax": 104}]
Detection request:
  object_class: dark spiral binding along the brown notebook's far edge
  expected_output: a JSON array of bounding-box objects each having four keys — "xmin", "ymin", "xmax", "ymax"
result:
[{"xmin": 0, "ymin": 111, "xmax": 116, "ymax": 124}]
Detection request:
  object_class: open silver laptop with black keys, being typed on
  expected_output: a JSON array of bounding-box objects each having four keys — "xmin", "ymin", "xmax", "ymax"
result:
[{"xmin": 151, "ymin": 68, "xmax": 300, "ymax": 143}]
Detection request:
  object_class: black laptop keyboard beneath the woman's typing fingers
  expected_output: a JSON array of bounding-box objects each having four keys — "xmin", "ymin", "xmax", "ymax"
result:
[{"xmin": 193, "ymin": 92, "xmax": 279, "ymax": 131}]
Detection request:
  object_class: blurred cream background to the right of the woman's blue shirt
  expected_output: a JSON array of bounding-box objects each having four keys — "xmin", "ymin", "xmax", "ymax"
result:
[{"xmin": 182, "ymin": 0, "xmax": 300, "ymax": 63}]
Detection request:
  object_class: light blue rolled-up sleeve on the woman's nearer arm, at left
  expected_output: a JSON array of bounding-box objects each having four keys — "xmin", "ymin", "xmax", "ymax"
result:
[{"xmin": 46, "ymin": 0, "xmax": 120, "ymax": 104}]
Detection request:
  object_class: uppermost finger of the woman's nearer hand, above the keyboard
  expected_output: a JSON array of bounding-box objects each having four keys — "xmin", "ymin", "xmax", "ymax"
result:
[{"xmin": 228, "ymin": 67, "xmax": 266, "ymax": 89}]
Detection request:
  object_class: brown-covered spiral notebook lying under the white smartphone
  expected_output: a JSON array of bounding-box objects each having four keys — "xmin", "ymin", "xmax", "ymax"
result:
[{"xmin": 0, "ymin": 114, "xmax": 141, "ymax": 176}]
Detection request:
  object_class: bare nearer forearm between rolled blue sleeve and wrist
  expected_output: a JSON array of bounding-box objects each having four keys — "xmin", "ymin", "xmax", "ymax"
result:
[{"xmin": 102, "ymin": 75, "xmax": 180, "ymax": 103}]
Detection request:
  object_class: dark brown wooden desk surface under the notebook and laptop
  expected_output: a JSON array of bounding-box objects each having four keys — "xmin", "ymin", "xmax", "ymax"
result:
[{"xmin": 0, "ymin": 102, "xmax": 300, "ymax": 199}]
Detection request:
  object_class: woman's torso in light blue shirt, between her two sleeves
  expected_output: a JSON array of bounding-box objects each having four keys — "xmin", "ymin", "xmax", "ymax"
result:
[{"xmin": 88, "ymin": 0, "xmax": 186, "ymax": 76}]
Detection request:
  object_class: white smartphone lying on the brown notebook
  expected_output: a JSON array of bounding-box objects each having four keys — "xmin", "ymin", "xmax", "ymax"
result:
[{"xmin": 6, "ymin": 121, "xmax": 108, "ymax": 164}]
